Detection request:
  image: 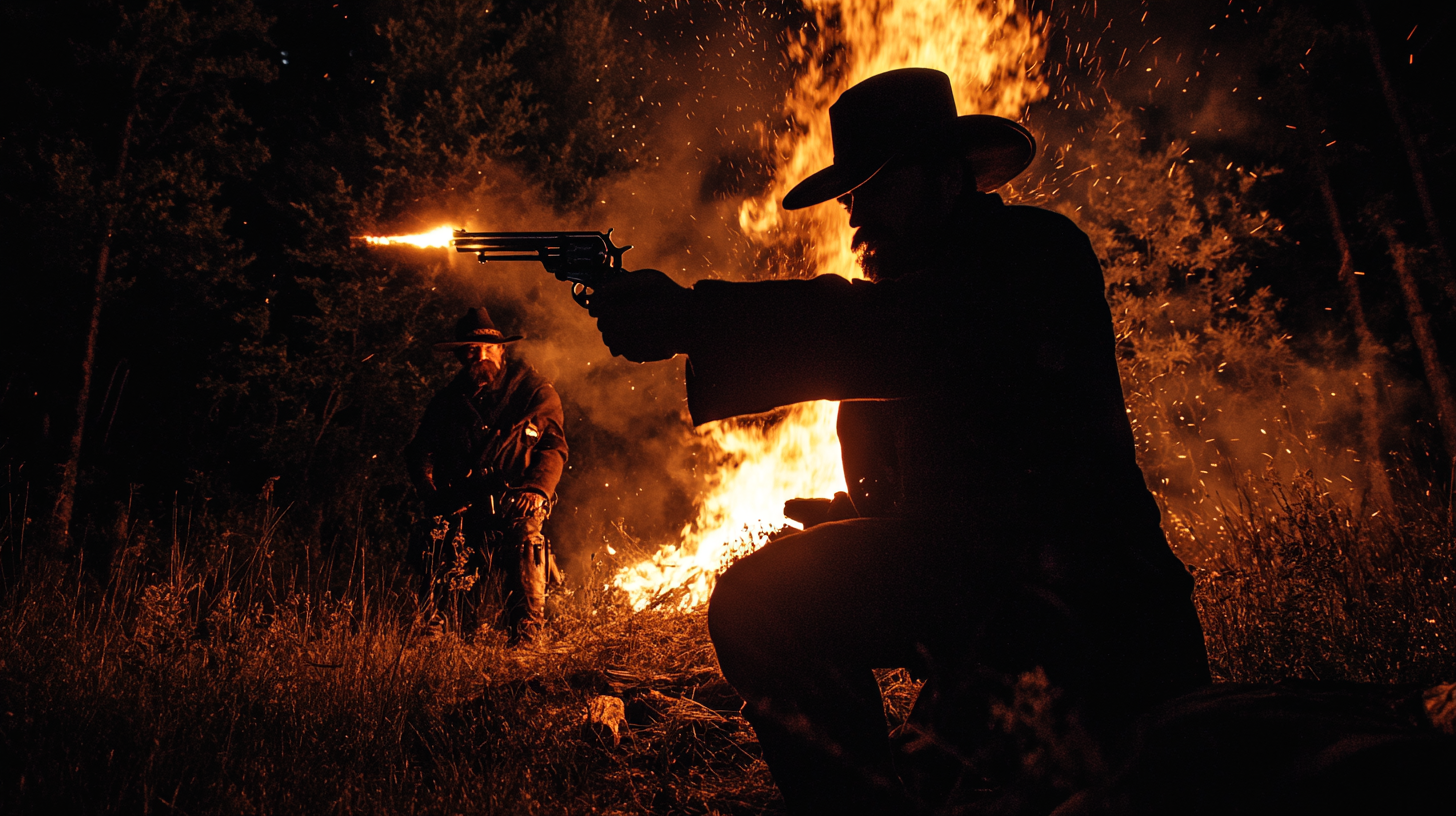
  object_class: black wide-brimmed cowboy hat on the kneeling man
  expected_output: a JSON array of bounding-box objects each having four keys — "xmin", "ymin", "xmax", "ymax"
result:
[{"xmin": 783, "ymin": 68, "xmax": 1037, "ymax": 210}]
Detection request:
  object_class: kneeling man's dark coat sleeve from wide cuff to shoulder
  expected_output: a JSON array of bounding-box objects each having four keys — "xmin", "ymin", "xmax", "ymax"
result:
[{"xmin": 687, "ymin": 207, "xmax": 1115, "ymax": 424}]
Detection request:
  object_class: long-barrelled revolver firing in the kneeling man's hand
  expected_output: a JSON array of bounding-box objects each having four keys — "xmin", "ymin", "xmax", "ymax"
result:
[{"xmin": 450, "ymin": 229, "xmax": 632, "ymax": 307}]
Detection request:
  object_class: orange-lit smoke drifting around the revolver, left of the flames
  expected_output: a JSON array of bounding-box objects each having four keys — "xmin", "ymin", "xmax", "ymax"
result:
[{"xmin": 407, "ymin": 6, "xmax": 809, "ymax": 578}]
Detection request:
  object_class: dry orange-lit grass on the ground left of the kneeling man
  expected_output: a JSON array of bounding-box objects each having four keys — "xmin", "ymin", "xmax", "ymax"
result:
[{"xmin": 0, "ymin": 542, "xmax": 778, "ymax": 815}]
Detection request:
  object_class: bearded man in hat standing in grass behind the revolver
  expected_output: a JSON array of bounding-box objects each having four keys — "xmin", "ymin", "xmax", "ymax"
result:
[{"xmin": 405, "ymin": 307, "xmax": 566, "ymax": 646}]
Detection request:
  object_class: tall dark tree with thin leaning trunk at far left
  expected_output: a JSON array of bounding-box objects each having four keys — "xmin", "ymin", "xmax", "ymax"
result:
[{"xmin": 6, "ymin": 0, "xmax": 271, "ymax": 549}]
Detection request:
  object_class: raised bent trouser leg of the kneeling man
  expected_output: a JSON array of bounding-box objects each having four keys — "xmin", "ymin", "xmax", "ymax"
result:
[{"xmin": 708, "ymin": 519, "xmax": 989, "ymax": 815}]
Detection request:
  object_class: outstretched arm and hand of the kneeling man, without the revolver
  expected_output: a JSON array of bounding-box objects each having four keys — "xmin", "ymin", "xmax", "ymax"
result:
[{"xmin": 591, "ymin": 270, "xmax": 965, "ymax": 424}]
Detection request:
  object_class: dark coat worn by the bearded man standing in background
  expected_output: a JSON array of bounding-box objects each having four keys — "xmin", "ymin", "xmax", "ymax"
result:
[{"xmin": 405, "ymin": 358, "xmax": 566, "ymax": 498}]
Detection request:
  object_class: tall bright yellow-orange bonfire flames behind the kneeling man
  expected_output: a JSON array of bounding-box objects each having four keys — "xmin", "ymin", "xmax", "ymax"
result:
[{"xmin": 616, "ymin": 0, "xmax": 1047, "ymax": 609}]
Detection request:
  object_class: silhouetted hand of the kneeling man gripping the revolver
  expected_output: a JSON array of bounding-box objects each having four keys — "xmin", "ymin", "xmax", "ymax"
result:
[{"xmin": 587, "ymin": 270, "xmax": 693, "ymax": 363}]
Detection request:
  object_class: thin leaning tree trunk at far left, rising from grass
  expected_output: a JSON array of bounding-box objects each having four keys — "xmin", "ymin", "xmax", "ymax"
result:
[{"xmin": 50, "ymin": 89, "xmax": 141, "ymax": 555}]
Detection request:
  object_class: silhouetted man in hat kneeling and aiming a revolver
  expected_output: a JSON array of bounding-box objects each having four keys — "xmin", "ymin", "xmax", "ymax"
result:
[{"xmin": 591, "ymin": 68, "xmax": 1208, "ymax": 815}]
